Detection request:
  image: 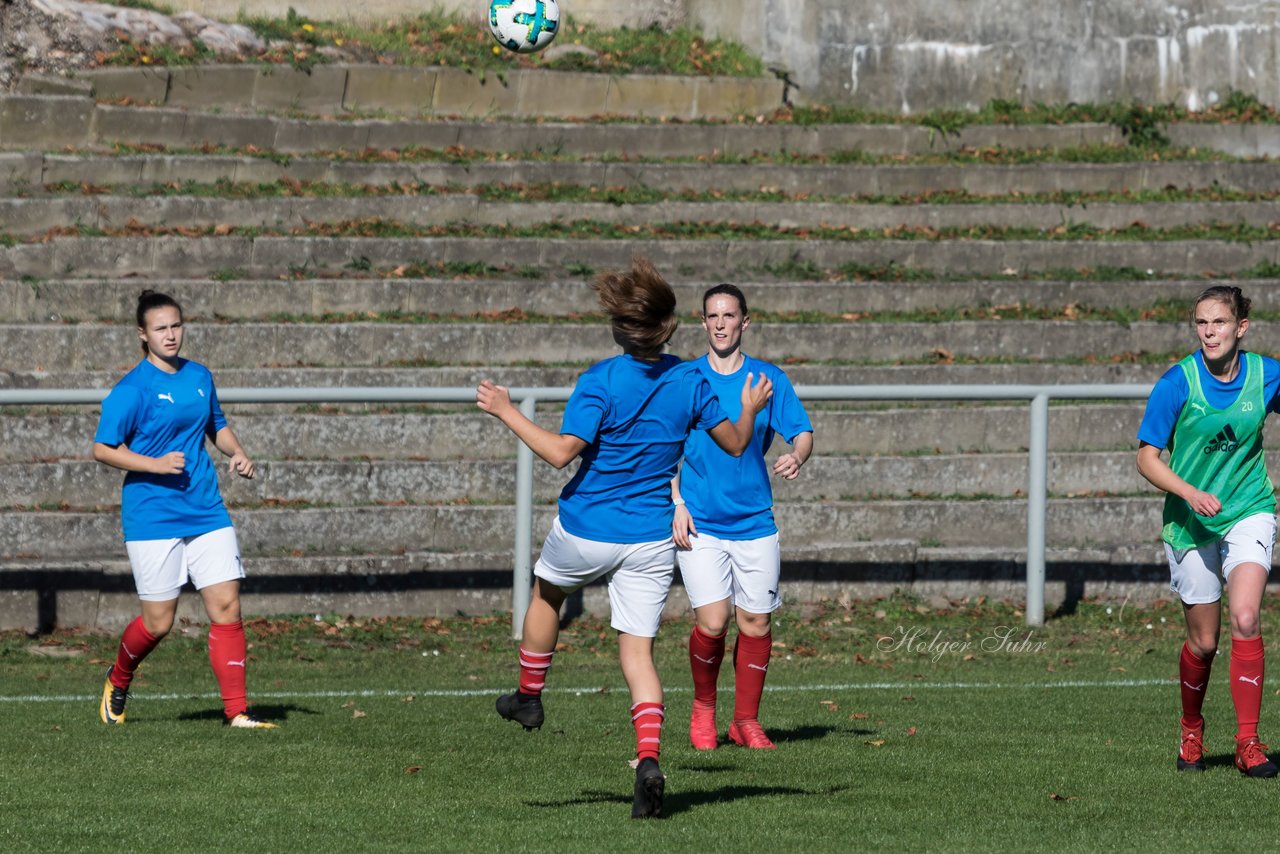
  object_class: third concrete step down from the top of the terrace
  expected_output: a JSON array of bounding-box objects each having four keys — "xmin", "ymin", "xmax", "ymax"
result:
[{"xmin": 12, "ymin": 153, "xmax": 1280, "ymax": 197}]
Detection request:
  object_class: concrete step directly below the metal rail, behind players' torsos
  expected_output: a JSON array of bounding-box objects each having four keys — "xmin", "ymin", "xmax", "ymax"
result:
[{"xmin": 0, "ymin": 407, "xmax": 1144, "ymax": 463}]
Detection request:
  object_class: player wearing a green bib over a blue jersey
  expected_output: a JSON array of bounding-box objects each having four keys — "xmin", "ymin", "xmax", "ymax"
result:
[{"xmin": 1138, "ymin": 286, "xmax": 1280, "ymax": 777}]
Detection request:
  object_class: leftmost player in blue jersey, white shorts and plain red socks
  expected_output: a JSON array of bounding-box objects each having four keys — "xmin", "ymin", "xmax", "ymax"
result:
[{"xmin": 93, "ymin": 291, "xmax": 275, "ymax": 729}]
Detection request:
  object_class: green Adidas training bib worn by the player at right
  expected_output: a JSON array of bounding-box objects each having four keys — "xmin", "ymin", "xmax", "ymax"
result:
[{"xmin": 1162, "ymin": 352, "xmax": 1276, "ymax": 549}]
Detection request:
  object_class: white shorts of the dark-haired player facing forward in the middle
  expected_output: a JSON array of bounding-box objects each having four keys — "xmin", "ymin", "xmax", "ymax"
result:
[{"xmin": 676, "ymin": 534, "xmax": 782, "ymax": 613}]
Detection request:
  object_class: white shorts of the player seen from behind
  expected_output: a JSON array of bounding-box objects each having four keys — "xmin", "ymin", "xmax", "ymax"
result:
[{"xmin": 534, "ymin": 516, "xmax": 676, "ymax": 638}]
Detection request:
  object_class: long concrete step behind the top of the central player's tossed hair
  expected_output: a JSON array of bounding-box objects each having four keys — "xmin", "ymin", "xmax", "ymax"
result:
[{"xmin": 0, "ymin": 232, "xmax": 1280, "ymax": 280}]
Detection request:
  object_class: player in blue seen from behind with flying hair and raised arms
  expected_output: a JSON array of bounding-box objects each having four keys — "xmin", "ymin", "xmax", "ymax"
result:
[{"xmin": 476, "ymin": 259, "xmax": 772, "ymax": 818}]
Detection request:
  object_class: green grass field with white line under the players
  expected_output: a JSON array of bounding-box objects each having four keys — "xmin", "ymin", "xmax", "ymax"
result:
[{"xmin": 0, "ymin": 597, "xmax": 1280, "ymax": 851}]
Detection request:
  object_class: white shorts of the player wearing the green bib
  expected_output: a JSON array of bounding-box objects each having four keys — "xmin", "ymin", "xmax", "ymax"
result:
[{"xmin": 1165, "ymin": 513, "xmax": 1276, "ymax": 604}]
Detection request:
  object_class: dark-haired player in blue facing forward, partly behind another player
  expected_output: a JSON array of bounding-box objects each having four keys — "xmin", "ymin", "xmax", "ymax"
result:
[{"xmin": 672, "ymin": 284, "xmax": 813, "ymax": 750}]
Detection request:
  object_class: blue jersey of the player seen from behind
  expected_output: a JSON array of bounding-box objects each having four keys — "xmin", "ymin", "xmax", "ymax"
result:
[{"xmin": 559, "ymin": 355, "xmax": 726, "ymax": 543}]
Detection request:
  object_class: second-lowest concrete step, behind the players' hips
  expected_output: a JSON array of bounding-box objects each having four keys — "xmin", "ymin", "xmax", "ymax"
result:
[{"xmin": 0, "ymin": 495, "xmax": 1162, "ymax": 560}]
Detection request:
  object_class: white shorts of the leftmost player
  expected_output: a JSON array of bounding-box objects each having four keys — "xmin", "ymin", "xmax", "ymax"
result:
[{"xmin": 124, "ymin": 526, "xmax": 244, "ymax": 602}]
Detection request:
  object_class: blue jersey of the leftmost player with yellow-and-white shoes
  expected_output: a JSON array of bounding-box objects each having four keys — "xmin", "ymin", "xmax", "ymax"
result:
[{"xmin": 93, "ymin": 360, "xmax": 232, "ymax": 540}]
